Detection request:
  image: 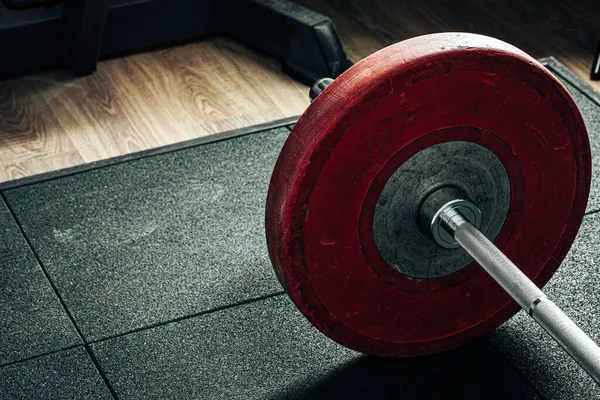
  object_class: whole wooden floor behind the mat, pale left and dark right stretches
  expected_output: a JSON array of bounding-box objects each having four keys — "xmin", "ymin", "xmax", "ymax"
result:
[{"xmin": 0, "ymin": 0, "xmax": 600, "ymax": 181}]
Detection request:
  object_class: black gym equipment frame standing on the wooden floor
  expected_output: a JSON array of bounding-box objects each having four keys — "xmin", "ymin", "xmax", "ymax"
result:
[{"xmin": 0, "ymin": 0, "xmax": 351, "ymax": 84}]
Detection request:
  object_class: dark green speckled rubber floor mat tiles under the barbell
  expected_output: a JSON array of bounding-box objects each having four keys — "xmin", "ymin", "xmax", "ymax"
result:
[{"xmin": 0, "ymin": 59, "xmax": 600, "ymax": 399}]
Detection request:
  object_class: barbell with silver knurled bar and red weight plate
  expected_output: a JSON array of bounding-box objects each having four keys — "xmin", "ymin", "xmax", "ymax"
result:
[{"xmin": 265, "ymin": 33, "xmax": 600, "ymax": 383}]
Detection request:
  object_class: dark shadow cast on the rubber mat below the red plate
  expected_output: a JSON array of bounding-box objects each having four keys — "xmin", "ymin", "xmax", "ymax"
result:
[{"xmin": 270, "ymin": 339, "xmax": 539, "ymax": 400}]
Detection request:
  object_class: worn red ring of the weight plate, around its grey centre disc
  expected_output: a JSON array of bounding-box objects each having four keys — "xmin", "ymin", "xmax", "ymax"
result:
[{"xmin": 266, "ymin": 33, "xmax": 591, "ymax": 357}]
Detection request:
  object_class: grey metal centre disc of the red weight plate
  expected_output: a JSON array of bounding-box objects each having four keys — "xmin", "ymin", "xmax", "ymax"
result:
[{"xmin": 373, "ymin": 141, "xmax": 510, "ymax": 278}]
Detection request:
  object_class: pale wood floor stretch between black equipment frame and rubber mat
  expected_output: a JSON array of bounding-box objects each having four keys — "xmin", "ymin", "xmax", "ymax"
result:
[{"xmin": 0, "ymin": 38, "xmax": 309, "ymax": 181}]
